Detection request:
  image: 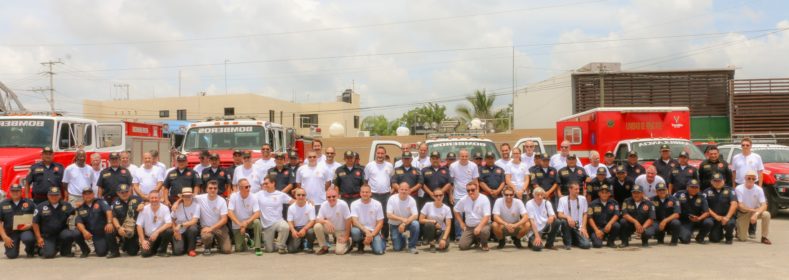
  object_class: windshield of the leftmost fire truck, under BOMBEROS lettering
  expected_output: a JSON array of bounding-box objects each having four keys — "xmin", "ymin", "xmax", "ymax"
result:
[{"xmin": 0, "ymin": 119, "xmax": 54, "ymax": 148}]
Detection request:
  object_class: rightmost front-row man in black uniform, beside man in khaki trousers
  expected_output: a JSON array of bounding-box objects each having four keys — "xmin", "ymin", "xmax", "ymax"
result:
[{"xmin": 704, "ymin": 173, "xmax": 737, "ymax": 244}]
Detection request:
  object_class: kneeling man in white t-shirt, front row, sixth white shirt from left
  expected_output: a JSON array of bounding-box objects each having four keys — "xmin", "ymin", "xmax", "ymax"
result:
[{"xmin": 288, "ymin": 188, "xmax": 315, "ymax": 253}]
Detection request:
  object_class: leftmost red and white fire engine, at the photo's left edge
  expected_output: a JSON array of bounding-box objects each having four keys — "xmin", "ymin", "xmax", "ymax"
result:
[{"xmin": 0, "ymin": 113, "xmax": 170, "ymax": 197}]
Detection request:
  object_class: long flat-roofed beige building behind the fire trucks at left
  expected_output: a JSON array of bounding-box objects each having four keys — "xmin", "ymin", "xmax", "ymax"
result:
[{"xmin": 82, "ymin": 89, "xmax": 361, "ymax": 137}]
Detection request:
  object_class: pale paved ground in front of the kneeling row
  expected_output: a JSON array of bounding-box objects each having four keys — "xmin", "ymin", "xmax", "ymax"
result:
[{"xmin": 0, "ymin": 211, "xmax": 789, "ymax": 280}]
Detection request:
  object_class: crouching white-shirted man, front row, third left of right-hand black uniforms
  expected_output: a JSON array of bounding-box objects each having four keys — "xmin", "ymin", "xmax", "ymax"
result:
[{"xmin": 493, "ymin": 186, "xmax": 531, "ymax": 249}]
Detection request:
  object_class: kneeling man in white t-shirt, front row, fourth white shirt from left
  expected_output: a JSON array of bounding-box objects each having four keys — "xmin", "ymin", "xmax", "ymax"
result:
[{"xmin": 227, "ymin": 179, "xmax": 263, "ymax": 256}]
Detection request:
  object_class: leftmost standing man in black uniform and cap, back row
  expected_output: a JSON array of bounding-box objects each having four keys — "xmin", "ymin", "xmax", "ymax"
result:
[{"xmin": 24, "ymin": 147, "xmax": 66, "ymax": 204}]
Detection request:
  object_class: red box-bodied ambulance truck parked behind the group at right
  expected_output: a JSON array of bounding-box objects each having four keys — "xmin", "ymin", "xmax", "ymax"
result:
[{"xmin": 556, "ymin": 107, "xmax": 704, "ymax": 166}]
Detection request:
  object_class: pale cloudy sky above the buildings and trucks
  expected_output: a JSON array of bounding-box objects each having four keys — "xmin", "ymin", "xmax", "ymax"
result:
[{"xmin": 0, "ymin": 0, "xmax": 789, "ymax": 121}]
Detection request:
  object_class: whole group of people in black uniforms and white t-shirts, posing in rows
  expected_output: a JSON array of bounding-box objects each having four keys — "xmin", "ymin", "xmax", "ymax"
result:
[{"xmin": 0, "ymin": 139, "xmax": 770, "ymax": 258}]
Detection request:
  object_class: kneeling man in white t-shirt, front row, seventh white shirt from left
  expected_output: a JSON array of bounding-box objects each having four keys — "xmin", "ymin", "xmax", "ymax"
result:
[{"xmin": 314, "ymin": 188, "xmax": 352, "ymax": 255}]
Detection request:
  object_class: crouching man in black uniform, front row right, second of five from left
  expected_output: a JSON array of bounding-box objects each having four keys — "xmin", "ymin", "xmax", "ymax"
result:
[{"xmin": 620, "ymin": 185, "xmax": 657, "ymax": 248}]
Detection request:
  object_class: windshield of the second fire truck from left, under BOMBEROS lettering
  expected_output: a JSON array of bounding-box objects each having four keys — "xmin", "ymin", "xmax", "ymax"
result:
[{"xmin": 183, "ymin": 125, "xmax": 266, "ymax": 152}]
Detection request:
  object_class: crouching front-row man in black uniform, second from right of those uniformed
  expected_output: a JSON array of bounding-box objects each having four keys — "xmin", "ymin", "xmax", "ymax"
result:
[{"xmin": 674, "ymin": 180, "xmax": 712, "ymax": 244}]
